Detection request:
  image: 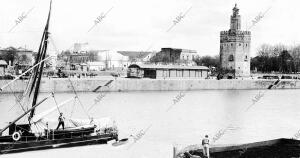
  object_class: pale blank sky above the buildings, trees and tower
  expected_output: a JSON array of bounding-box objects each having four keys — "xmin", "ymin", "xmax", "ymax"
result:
[{"xmin": 0, "ymin": 0, "xmax": 300, "ymax": 56}]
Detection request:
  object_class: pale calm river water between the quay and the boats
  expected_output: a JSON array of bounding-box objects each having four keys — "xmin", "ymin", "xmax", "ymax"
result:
[{"xmin": 0, "ymin": 90, "xmax": 300, "ymax": 158}]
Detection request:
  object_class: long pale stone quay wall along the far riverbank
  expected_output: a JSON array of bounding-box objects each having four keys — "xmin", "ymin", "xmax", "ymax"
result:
[{"xmin": 0, "ymin": 76, "xmax": 300, "ymax": 93}]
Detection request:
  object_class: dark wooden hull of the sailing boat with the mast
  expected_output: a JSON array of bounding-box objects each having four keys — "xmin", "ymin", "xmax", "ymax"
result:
[{"xmin": 0, "ymin": 134, "xmax": 116, "ymax": 154}]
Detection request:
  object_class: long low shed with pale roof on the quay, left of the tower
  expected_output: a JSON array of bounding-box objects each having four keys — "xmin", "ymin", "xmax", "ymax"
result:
[{"xmin": 127, "ymin": 64, "xmax": 209, "ymax": 78}]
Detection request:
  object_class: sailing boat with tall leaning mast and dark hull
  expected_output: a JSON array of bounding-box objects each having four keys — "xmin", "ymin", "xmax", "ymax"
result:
[{"xmin": 0, "ymin": 2, "xmax": 118, "ymax": 154}]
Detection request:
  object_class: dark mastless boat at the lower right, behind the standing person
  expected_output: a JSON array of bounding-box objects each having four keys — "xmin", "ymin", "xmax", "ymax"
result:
[{"xmin": 174, "ymin": 138, "xmax": 300, "ymax": 158}]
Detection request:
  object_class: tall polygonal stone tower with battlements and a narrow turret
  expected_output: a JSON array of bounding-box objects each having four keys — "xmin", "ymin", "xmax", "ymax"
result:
[{"xmin": 220, "ymin": 4, "xmax": 251, "ymax": 77}]
